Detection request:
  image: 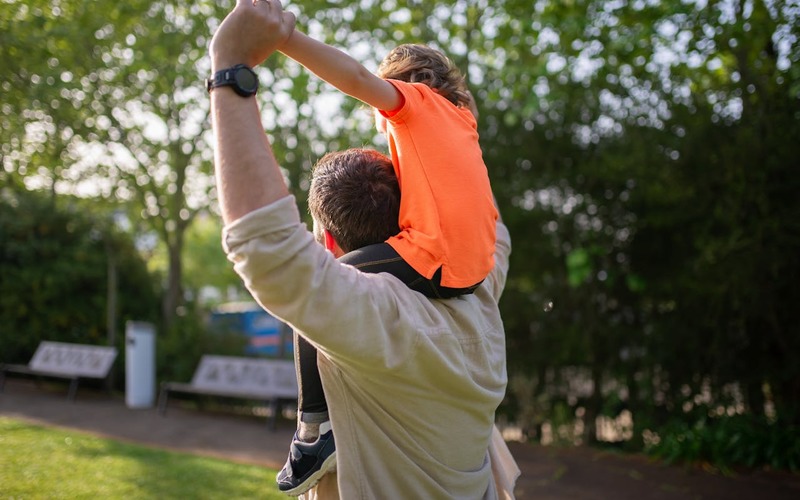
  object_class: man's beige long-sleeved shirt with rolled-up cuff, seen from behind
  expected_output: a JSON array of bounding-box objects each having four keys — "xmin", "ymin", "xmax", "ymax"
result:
[{"xmin": 225, "ymin": 198, "xmax": 510, "ymax": 498}]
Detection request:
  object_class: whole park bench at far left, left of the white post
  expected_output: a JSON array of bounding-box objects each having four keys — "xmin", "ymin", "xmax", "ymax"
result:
[{"xmin": 0, "ymin": 340, "xmax": 117, "ymax": 401}]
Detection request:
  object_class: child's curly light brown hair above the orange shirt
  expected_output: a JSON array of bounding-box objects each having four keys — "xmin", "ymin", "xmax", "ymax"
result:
[{"xmin": 377, "ymin": 44, "xmax": 472, "ymax": 106}]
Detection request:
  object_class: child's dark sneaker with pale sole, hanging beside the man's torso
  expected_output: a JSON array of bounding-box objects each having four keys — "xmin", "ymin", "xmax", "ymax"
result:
[{"xmin": 275, "ymin": 430, "xmax": 336, "ymax": 496}]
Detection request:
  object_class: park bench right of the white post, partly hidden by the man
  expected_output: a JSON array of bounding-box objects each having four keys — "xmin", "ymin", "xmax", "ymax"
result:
[{"xmin": 158, "ymin": 355, "xmax": 297, "ymax": 429}]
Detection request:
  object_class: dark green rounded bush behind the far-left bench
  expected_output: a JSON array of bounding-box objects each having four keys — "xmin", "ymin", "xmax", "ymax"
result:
[{"xmin": 0, "ymin": 190, "xmax": 157, "ymax": 363}]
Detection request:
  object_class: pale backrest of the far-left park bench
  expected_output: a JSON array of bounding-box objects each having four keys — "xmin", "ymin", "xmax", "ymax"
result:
[{"xmin": 28, "ymin": 341, "xmax": 117, "ymax": 378}]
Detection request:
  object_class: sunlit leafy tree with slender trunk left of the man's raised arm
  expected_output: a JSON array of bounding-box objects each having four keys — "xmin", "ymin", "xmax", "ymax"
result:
[{"xmin": 0, "ymin": 0, "xmax": 238, "ymax": 323}]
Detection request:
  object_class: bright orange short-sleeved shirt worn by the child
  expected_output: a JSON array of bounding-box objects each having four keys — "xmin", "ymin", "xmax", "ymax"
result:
[{"xmin": 381, "ymin": 80, "xmax": 497, "ymax": 288}]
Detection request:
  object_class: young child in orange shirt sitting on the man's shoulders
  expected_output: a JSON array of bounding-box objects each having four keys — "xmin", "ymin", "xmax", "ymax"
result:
[{"xmin": 277, "ymin": 30, "xmax": 497, "ymax": 495}]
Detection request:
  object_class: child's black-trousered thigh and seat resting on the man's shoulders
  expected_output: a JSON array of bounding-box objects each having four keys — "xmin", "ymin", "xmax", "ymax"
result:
[{"xmin": 339, "ymin": 243, "xmax": 480, "ymax": 299}]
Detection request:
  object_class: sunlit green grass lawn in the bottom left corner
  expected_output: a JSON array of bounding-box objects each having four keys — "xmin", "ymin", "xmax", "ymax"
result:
[{"xmin": 0, "ymin": 417, "xmax": 287, "ymax": 500}]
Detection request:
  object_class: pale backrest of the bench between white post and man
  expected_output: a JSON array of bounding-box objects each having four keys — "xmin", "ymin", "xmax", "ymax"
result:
[{"xmin": 192, "ymin": 355, "xmax": 297, "ymax": 398}]
